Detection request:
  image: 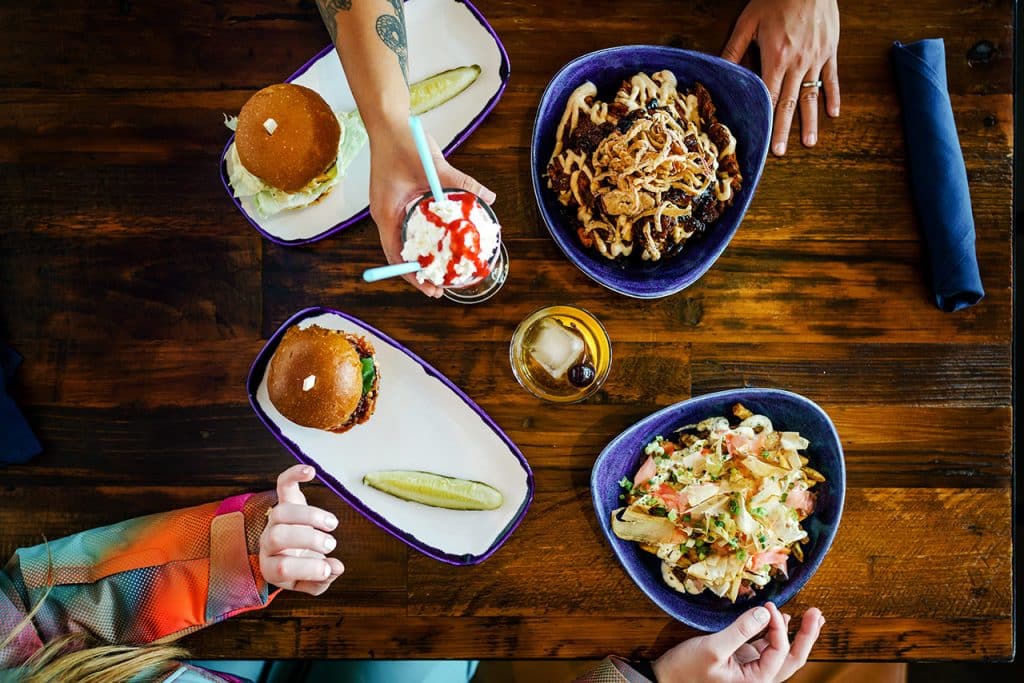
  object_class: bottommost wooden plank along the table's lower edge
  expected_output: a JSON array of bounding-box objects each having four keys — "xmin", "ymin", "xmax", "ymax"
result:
[{"xmin": 182, "ymin": 613, "xmax": 1013, "ymax": 661}]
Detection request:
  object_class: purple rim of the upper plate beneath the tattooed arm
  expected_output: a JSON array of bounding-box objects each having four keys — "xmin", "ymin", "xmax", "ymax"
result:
[{"xmin": 219, "ymin": 0, "xmax": 512, "ymax": 247}]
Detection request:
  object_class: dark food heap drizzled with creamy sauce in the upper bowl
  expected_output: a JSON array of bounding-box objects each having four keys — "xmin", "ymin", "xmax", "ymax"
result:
[{"xmin": 548, "ymin": 71, "xmax": 741, "ymax": 261}]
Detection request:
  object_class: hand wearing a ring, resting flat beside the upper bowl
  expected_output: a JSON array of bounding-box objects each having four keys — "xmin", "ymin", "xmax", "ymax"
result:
[{"xmin": 722, "ymin": 0, "xmax": 839, "ymax": 156}]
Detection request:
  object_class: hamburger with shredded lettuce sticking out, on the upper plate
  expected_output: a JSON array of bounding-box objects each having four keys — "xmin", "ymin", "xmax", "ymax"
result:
[{"xmin": 225, "ymin": 83, "xmax": 367, "ymax": 218}]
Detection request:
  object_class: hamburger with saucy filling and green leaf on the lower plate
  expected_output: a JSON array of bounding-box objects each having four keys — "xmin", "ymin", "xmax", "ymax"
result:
[{"xmin": 267, "ymin": 325, "xmax": 380, "ymax": 433}]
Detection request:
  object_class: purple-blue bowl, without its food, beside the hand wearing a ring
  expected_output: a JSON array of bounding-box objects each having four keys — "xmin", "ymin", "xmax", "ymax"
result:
[{"xmin": 530, "ymin": 45, "xmax": 772, "ymax": 299}]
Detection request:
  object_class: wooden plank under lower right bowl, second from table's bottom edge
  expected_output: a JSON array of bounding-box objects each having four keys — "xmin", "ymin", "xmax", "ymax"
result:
[{"xmin": 409, "ymin": 488, "xmax": 1012, "ymax": 620}]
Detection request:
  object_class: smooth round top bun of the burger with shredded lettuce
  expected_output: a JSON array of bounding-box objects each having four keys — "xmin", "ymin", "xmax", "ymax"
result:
[{"xmin": 234, "ymin": 83, "xmax": 341, "ymax": 193}]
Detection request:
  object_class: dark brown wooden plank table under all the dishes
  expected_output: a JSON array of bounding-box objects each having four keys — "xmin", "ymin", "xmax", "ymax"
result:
[{"xmin": 0, "ymin": 0, "xmax": 1013, "ymax": 659}]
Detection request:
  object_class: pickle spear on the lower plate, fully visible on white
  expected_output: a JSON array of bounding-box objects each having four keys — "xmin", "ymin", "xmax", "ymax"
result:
[{"xmin": 362, "ymin": 470, "xmax": 505, "ymax": 510}]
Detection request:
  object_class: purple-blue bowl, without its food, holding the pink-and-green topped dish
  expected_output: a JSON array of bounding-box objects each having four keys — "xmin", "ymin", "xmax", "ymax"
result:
[{"xmin": 590, "ymin": 389, "xmax": 846, "ymax": 631}]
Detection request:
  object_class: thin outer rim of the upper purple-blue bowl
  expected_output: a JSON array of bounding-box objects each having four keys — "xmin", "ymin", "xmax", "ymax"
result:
[{"xmin": 529, "ymin": 44, "xmax": 771, "ymax": 300}]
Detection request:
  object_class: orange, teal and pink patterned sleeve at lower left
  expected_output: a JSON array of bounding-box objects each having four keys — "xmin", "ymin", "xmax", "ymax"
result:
[{"xmin": 0, "ymin": 493, "xmax": 276, "ymax": 669}]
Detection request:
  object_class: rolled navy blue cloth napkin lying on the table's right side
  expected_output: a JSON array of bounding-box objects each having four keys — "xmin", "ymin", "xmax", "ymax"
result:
[{"xmin": 891, "ymin": 38, "xmax": 985, "ymax": 312}]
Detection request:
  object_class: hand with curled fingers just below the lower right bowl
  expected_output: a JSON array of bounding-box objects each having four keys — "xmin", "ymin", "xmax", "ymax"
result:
[{"xmin": 652, "ymin": 602, "xmax": 825, "ymax": 683}]
